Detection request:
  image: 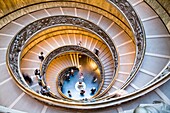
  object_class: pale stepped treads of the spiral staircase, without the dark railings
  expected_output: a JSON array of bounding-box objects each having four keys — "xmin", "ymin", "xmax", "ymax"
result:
[{"xmin": 0, "ymin": 0, "xmax": 170, "ymax": 113}]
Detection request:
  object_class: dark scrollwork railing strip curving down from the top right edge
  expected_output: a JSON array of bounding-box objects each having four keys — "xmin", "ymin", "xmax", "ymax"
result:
[{"xmin": 109, "ymin": 0, "xmax": 146, "ymax": 88}]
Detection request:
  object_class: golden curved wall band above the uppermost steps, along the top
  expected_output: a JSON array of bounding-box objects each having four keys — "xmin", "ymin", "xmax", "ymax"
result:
[{"xmin": 0, "ymin": 0, "xmax": 132, "ymax": 37}]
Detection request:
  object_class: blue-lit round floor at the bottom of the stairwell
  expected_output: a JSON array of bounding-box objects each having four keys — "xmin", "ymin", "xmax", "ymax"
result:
[{"xmin": 61, "ymin": 70, "xmax": 99, "ymax": 100}]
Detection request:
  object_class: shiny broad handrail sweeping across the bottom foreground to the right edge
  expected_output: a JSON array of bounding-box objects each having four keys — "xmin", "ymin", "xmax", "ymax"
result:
[{"xmin": 6, "ymin": 50, "xmax": 170, "ymax": 109}]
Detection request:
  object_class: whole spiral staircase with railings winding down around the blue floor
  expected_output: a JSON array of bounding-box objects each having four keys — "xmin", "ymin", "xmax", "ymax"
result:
[{"xmin": 0, "ymin": 0, "xmax": 170, "ymax": 113}]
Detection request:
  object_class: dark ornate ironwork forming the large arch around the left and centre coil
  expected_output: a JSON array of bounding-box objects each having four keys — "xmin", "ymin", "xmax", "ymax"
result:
[{"xmin": 7, "ymin": 16, "xmax": 118, "ymax": 87}]
